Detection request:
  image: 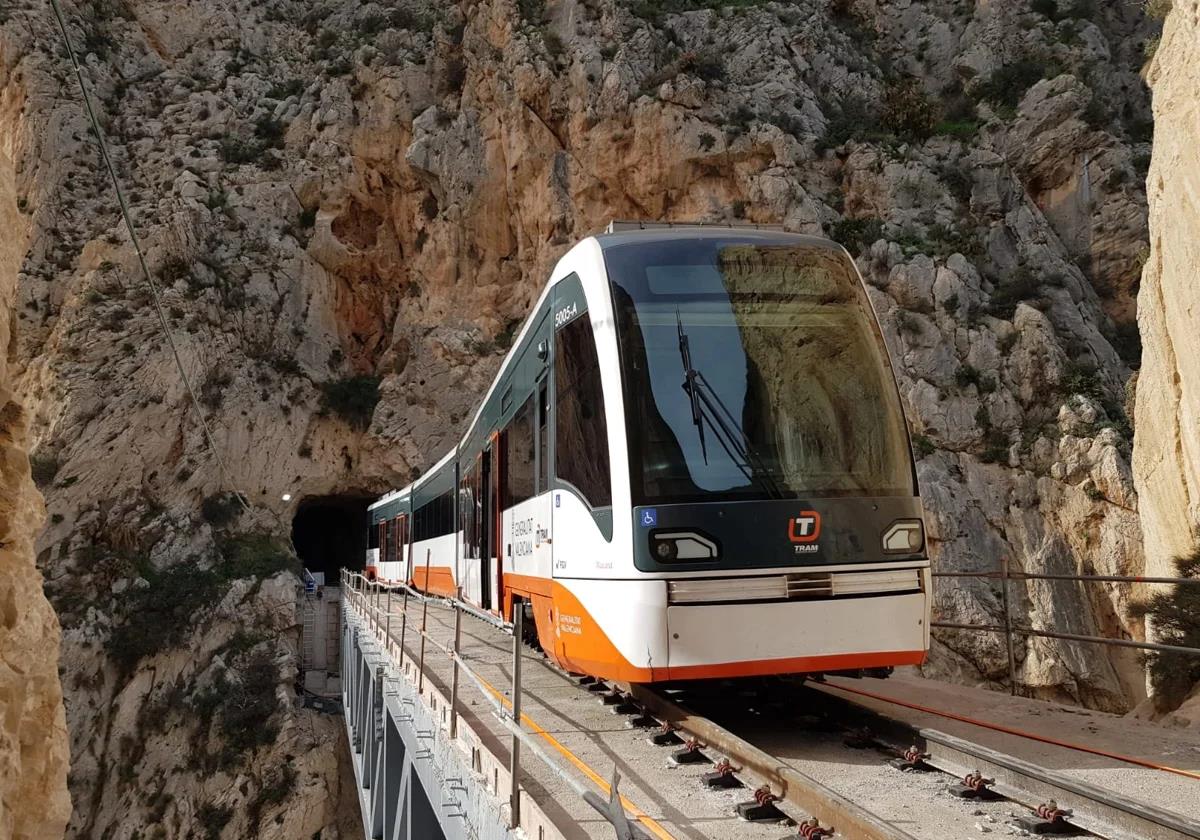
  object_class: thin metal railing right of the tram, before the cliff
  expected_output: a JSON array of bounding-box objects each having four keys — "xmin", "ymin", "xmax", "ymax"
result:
[{"xmin": 930, "ymin": 557, "xmax": 1200, "ymax": 695}]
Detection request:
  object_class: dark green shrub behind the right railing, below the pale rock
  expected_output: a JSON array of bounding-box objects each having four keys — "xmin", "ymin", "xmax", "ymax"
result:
[{"xmin": 1129, "ymin": 548, "xmax": 1200, "ymax": 712}]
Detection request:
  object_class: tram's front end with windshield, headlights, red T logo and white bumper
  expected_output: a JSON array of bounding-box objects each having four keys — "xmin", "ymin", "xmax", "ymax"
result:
[{"xmin": 602, "ymin": 229, "xmax": 930, "ymax": 679}]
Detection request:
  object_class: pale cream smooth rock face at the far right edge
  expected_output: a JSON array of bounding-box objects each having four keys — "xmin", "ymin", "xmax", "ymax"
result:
[{"xmin": 1133, "ymin": 0, "xmax": 1200, "ymax": 583}]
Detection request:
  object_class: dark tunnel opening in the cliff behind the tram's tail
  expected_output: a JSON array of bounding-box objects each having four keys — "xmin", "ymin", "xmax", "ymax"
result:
[{"xmin": 292, "ymin": 496, "xmax": 374, "ymax": 587}]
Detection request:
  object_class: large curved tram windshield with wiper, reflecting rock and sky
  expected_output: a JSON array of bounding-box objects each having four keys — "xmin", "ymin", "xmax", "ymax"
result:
[{"xmin": 605, "ymin": 236, "xmax": 914, "ymax": 504}]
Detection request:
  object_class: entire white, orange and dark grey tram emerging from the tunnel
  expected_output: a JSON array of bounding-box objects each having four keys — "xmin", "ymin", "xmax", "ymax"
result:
[{"xmin": 368, "ymin": 223, "xmax": 930, "ymax": 683}]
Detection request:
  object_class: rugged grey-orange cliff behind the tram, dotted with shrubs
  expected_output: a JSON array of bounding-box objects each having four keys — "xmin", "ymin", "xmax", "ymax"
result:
[{"xmin": 0, "ymin": 0, "xmax": 1157, "ymax": 836}]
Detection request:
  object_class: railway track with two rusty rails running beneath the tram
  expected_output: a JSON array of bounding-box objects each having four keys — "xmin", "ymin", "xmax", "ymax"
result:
[{"xmin": 369, "ymin": 590, "xmax": 1200, "ymax": 840}]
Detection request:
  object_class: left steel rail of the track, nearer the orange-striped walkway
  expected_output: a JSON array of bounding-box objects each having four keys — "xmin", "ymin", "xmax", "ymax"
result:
[{"xmin": 624, "ymin": 684, "xmax": 916, "ymax": 840}]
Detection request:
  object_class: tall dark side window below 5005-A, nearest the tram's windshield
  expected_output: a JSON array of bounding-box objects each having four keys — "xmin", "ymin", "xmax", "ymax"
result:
[{"xmin": 554, "ymin": 316, "xmax": 612, "ymax": 508}]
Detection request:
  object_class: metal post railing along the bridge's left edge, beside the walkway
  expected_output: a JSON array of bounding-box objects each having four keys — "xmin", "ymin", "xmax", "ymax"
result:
[{"xmin": 341, "ymin": 569, "xmax": 647, "ymax": 840}]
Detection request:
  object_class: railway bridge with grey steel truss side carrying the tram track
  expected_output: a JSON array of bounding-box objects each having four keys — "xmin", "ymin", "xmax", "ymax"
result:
[{"xmin": 338, "ymin": 570, "xmax": 1200, "ymax": 840}]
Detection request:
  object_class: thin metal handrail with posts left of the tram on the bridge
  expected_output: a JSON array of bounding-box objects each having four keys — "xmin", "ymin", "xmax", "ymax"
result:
[{"xmin": 341, "ymin": 569, "xmax": 646, "ymax": 840}]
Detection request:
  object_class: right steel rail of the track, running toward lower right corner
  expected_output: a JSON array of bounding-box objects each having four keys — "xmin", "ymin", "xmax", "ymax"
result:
[{"xmin": 806, "ymin": 683, "xmax": 1200, "ymax": 840}]
